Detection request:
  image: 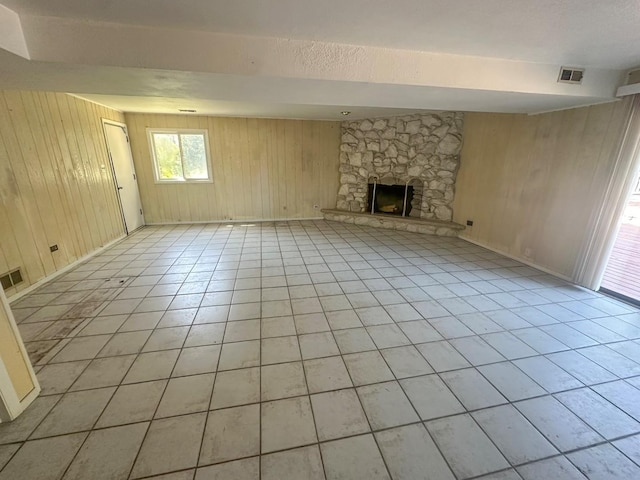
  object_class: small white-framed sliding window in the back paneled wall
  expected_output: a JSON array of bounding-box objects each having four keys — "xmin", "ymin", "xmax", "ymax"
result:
[{"xmin": 147, "ymin": 129, "xmax": 213, "ymax": 183}]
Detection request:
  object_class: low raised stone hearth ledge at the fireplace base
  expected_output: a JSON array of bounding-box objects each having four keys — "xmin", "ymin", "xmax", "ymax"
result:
[{"xmin": 322, "ymin": 209, "xmax": 464, "ymax": 237}]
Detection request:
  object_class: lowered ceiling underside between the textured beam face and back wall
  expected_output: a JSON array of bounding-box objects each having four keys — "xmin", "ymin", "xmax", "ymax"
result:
[{"xmin": 0, "ymin": 51, "xmax": 612, "ymax": 120}]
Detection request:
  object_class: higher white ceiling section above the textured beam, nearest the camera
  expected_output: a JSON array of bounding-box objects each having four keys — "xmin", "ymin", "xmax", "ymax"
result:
[{"xmin": 2, "ymin": 0, "xmax": 640, "ymax": 68}]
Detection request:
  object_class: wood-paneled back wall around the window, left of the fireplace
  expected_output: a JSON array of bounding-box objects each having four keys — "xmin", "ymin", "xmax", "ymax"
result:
[{"xmin": 125, "ymin": 114, "xmax": 340, "ymax": 223}]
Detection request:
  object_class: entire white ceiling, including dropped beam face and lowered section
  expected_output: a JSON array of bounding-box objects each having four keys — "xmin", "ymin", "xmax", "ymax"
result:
[{"xmin": 0, "ymin": 0, "xmax": 640, "ymax": 120}]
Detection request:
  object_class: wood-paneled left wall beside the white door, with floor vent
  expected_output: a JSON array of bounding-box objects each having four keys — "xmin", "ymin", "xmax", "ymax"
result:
[{"xmin": 0, "ymin": 91, "xmax": 124, "ymax": 297}]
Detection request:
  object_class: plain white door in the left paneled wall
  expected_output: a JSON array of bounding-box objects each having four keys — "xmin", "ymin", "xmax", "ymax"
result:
[{"xmin": 104, "ymin": 121, "xmax": 144, "ymax": 234}]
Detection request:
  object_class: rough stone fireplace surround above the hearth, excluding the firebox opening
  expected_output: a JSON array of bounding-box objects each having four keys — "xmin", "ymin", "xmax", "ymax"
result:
[{"xmin": 336, "ymin": 112, "xmax": 463, "ymax": 221}]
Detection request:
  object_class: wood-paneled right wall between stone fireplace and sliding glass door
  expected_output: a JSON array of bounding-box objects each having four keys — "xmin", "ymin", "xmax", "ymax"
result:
[{"xmin": 454, "ymin": 97, "xmax": 632, "ymax": 278}]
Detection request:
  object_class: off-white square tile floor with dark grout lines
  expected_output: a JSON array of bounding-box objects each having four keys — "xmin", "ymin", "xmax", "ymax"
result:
[{"xmin": 0, "ymin": 221, "xmax": 640, "ymax": 480}]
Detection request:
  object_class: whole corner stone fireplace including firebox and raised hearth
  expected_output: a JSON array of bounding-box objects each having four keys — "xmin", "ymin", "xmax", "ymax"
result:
[{"xmin": 324, "ymin": 112, "xmax": 464, "ymax": 236}]
